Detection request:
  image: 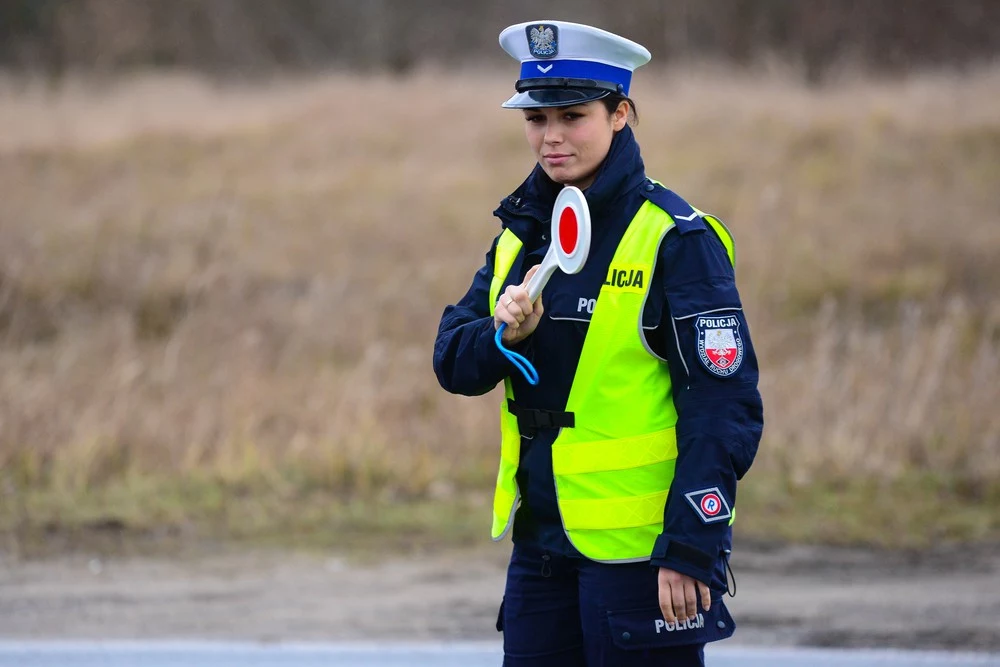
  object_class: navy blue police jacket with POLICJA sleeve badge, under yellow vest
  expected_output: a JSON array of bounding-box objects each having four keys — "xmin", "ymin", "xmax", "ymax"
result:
[{"xmin": 434, "ymin": 126, "xmax": 763, "ymax": 593}]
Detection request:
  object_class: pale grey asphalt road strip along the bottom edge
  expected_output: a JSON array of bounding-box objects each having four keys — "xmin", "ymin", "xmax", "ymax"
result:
[{"xmin": 0, "ymin": 641, "xmax": 1000, "ymax": 667}]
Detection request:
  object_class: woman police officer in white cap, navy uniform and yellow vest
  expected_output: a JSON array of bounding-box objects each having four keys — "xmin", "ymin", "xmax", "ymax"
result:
[{"xmin": 434, "ymin": 21, "xmax": 763, "ymax": 667}]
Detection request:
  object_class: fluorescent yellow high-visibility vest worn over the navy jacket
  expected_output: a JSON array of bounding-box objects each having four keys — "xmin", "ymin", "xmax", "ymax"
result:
[{"xmin": 490, "ymin": 201, "xmax": 735, "ymax": 563}]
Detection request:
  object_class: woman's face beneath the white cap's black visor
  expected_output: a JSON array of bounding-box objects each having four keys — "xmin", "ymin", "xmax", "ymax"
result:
[{"xmin": 524, "ymin": 100, "xmax": 628, "ymax": 190}]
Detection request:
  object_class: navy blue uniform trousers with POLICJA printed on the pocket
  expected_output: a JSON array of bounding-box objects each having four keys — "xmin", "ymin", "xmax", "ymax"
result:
[{"xmin": 497, "ymin": 544, "xmax": 733, "ymax": 667}]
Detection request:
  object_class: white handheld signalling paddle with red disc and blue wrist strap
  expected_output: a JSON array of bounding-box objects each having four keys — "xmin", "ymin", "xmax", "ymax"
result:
[{"xmin": 495, "ymin": 185, "xmax": 590, "ymax": 384}]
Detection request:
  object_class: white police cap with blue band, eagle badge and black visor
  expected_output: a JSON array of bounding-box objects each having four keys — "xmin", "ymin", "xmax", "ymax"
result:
[{"xmin": 500, "ymin": 21, "xmax": 652, "ymax": 109}]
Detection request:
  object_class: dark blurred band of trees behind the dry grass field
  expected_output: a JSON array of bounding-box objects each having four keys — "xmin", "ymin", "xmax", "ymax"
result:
[{"xmin": 0, "ymin": 0, "xmax": 1000, "ymax": 83}]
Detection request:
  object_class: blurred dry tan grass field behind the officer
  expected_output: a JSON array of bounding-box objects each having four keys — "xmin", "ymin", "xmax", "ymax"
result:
[{"xmin": 0, "ymin": 68, "xmax": 1000, "ymax": 547}]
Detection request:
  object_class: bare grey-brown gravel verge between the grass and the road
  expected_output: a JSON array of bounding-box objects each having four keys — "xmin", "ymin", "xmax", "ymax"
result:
[{"xmin": 0, "ymin": 545, "xmax": 1000, "ymax": 651}]
